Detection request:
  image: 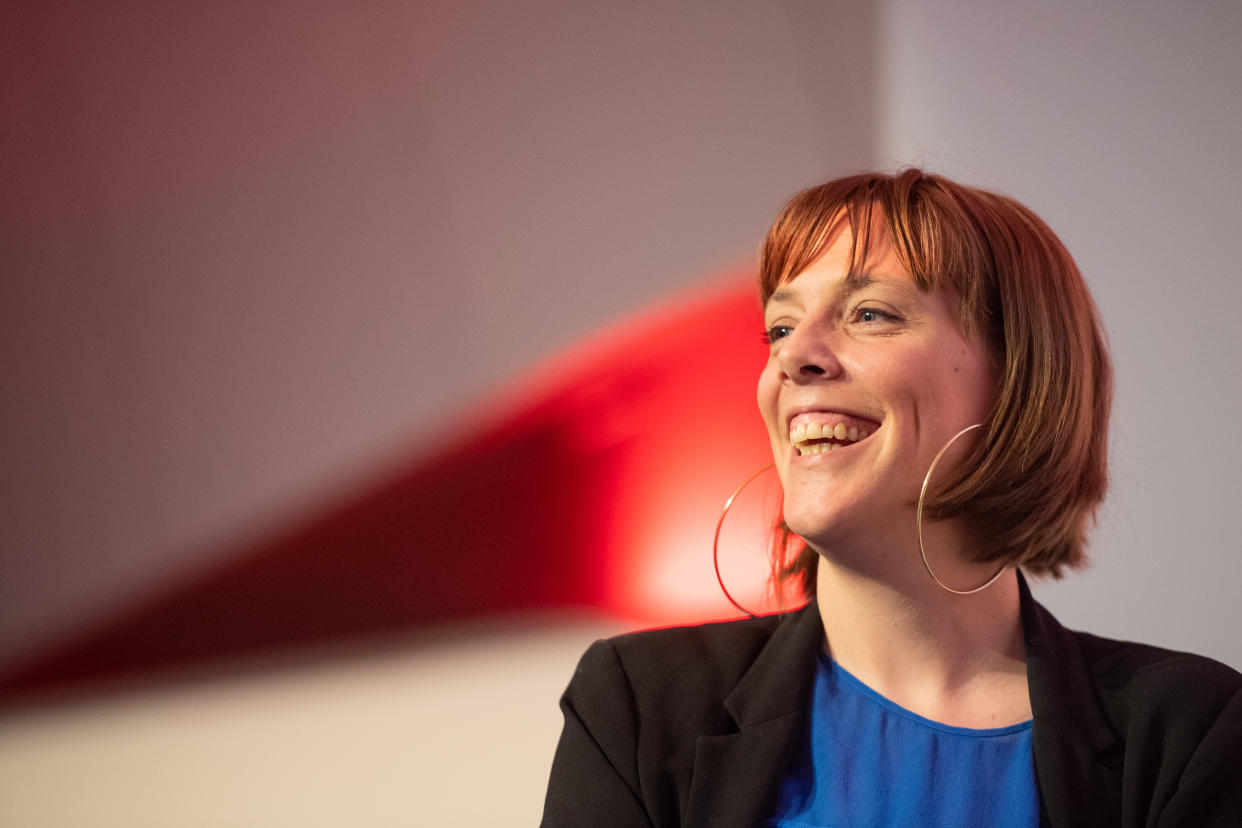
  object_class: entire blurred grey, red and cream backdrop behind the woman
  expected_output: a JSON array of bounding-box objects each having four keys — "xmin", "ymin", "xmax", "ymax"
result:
[{"xmin": 0, "ymin": 0, "xmax": 1242, "ymax": 827}]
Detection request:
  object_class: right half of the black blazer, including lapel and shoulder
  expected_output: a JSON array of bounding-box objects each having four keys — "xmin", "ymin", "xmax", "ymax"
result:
[{"xmin": 1023, "ymin": 588, "xmax": 1242, "ymax": 826}]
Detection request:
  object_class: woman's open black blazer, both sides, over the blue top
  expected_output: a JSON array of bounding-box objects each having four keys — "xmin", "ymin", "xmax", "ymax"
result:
[{"xmin": 543, "ymin": 578, "xmax": 1242, "ymax": 828}]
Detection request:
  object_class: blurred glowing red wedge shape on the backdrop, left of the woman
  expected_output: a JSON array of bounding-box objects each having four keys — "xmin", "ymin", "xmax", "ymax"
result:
[{"xmin": 4, "ymin": 274, "xmax": 794, "ymax": 693}]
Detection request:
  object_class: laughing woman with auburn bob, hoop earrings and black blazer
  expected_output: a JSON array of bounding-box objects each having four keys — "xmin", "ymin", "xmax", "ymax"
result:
[{"xmin": 544, "ymin": 170, "xmax": 1242, "ymax": 826}]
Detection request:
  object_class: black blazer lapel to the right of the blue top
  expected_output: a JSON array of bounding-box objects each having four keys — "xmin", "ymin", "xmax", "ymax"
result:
[{"xmin": 1018, "ymin": 574, "xmax": 1122, "ymax": 828}]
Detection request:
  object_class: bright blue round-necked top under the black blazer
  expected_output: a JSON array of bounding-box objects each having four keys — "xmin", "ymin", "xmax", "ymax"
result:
[{"xmin": 765, "ymin": 657, "xmax": 1040, "ymax": 828}]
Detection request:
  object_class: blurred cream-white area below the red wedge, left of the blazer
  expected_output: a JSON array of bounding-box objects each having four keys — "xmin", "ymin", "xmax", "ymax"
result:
[{"xmin": 0, "ymin": 614, "xmax": 623, "ymax": 828}]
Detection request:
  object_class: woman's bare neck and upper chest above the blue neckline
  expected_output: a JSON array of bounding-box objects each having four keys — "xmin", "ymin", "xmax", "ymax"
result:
[{"xmin": 816, "ymin": 546, "xmax": 1030, "ymax": 727}]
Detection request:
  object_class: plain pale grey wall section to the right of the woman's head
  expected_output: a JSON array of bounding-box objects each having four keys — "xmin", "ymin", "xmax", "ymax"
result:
[{"xmin": 878, "ymin": 0, "xmax": 1242, "ymax": 668}]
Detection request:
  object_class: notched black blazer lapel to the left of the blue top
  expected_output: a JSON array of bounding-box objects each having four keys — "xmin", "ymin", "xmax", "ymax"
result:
[{"xmin": 683, "ymin": 601, "xmax": 823, "ymax": 828}]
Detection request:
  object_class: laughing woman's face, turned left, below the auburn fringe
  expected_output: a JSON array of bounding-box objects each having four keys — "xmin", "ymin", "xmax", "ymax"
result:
[{"xmin": 758, "ymin": 222, "xmax": 997, "ymax": 551}]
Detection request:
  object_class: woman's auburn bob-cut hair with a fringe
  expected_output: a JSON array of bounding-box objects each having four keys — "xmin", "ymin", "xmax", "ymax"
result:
[{"xmin": 759, "ymin": 169, "xmax": 1113, "ymax": 598}]
